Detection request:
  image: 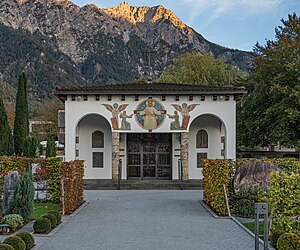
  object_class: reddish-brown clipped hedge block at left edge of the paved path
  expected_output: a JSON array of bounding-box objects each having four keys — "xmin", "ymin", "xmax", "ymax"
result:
[{"xmin": 60, "ymin": 160, "xmax": 84, "ymax": 214}]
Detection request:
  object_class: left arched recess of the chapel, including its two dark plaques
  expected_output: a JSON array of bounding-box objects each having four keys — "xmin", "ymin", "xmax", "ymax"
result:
[{"xmin": 75, "ymin": 114, "xmax": 112, "ymax": 179}]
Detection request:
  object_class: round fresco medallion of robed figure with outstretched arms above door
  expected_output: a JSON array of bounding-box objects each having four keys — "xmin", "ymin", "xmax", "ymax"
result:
[{"xmin": 134, "ymin": 98, "xmax": 166, "ymax": 132}]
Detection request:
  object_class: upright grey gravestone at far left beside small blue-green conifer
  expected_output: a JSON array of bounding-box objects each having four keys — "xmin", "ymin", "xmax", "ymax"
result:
[{"xmin": 3, "ymin": 171, "xmax": 20, "ymax": 215}]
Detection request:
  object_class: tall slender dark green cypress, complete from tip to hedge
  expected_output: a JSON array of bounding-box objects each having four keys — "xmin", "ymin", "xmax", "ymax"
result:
[{"xmin": 14, "ymin": 73, "xmax": 29, "ymax": 155}]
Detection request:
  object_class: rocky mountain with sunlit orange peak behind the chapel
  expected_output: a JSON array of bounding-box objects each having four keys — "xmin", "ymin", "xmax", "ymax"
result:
[{"xmin": 0, "ymin": 0, "xmax": 252, "ymax": 98}]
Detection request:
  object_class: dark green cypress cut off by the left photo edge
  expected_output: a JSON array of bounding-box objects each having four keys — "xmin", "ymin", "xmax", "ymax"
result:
[{"xmin": 0, "ymin": 97, "xmax": 14, "ymax": 155}]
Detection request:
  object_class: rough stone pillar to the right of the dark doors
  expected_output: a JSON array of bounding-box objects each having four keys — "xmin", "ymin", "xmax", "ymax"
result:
[{"xmin": 180, "ymin": 132, "xmax": 189, "ymax": 181}]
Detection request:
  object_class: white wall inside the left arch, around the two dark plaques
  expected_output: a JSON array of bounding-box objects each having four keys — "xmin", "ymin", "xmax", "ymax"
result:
[{"xmin": 76, "ymin": 115, "xmax": 112, "ymax": 179}]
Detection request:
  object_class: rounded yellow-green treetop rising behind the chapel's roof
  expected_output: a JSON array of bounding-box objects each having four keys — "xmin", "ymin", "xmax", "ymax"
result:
[{"xmin": 157, "ymin": 53, "xmax": 245, "ymax": 85}]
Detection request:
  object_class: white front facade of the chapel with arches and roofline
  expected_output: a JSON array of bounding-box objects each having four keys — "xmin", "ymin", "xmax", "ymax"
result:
[{"xmin": 57, "ymin": 83, "xmax": 245, "ymax": 180}]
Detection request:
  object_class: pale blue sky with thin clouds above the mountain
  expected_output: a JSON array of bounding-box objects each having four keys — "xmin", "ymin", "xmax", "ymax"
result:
[{"xmin": 70, "ymin": 0, "xmax": 300, "ymax": 51}]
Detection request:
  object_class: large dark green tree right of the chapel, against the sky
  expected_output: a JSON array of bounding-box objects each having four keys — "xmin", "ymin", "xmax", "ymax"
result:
[{"xmin": 237, "ymin": 13, "xmax": 300, "ymax": 147}]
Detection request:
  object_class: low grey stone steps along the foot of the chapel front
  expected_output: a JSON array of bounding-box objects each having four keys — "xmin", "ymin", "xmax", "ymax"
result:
[{"xmin": 84, "ymin": 180, "xmax": 203, "ymax": 190}]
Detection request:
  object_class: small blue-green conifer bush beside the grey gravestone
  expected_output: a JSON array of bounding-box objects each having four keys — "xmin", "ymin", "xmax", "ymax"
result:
[{"xmin": 9, "ymin": 171, "xmax": 35, "ymax": 221}]
